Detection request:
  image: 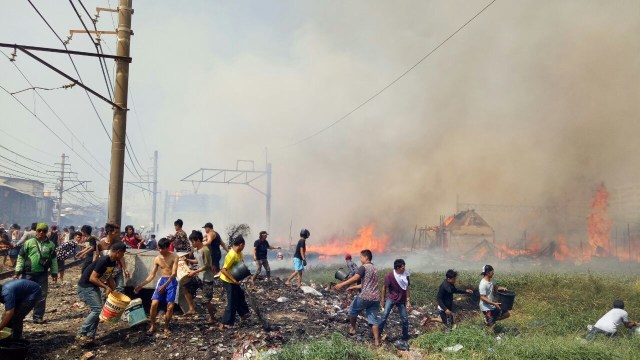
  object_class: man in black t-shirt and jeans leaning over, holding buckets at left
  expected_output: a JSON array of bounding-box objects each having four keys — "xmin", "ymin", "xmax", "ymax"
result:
[{"xmin": 76, "ymin": 242, "xmax": 127, "ymax": 343}]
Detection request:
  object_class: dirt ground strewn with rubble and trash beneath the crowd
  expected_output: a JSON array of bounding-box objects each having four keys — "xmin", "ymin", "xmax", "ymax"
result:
[{"xmin": 3, "ymin": 267, "xmax": 472, "ymax": 360}]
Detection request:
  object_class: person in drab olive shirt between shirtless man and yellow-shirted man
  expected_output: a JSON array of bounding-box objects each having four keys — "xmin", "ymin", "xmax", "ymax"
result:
[{"xmin": 185, "ymin": 230, "xmax": 217, "ymax": 324}]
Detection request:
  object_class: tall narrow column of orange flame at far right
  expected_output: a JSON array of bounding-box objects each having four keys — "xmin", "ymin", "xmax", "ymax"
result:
[{"xmin": 587, "ymin": 184, "xmax": 613, "ymax": 256}]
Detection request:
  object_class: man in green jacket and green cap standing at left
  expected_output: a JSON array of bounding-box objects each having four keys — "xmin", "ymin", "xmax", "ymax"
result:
[{"xmin": 15, "ymin": 223, "xmax": 58, "ymax": 324}]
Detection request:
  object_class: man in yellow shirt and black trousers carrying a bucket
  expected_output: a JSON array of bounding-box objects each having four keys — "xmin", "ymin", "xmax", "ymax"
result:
[{"xmin": 219, "ymin": 236, "xmax": 249, "ymax": 330}]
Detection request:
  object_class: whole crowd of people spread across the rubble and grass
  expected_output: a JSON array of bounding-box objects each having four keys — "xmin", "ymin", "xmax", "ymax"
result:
[{"xmin": 0, "ymin": 219, "xmax": 638, "ymax": 346}]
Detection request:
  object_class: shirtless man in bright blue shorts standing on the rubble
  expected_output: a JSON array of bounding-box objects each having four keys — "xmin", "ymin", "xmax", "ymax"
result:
[{"xmin": 134, "ymin": 238, "xmax": 178, "ymax": 335}]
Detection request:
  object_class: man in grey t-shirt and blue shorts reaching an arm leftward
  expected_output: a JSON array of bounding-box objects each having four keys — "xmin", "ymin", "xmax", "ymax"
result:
[{"xmin": 335, "ymin": 250, "xmax": 380, "ymax": 346}]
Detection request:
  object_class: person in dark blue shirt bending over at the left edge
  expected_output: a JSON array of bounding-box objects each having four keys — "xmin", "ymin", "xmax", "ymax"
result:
[{"xmin": 0, "ymin": 279, "xmax": 42, "ymax": 339}]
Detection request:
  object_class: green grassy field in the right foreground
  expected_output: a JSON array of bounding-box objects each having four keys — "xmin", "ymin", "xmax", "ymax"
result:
[{"xmin": 277, "ymin": 269, "xmax": 640, "ymax": 359}]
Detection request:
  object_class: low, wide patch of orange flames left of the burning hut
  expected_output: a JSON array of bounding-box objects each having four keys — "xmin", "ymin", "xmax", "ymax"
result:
[{"xmin": 309, "ymin": 224, "xmax": 389, "ymax": 256}]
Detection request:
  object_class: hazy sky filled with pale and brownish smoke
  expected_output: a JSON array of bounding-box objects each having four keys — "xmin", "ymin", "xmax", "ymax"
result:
[{"xmin": 0, "ymin": 0, "xmax": 640, "ymax": 243}]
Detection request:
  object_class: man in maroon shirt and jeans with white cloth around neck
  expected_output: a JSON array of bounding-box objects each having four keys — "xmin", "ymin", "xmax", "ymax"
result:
[{"xmin": 379, "ymin": 259, "xmax": 411, "ymax": 341}]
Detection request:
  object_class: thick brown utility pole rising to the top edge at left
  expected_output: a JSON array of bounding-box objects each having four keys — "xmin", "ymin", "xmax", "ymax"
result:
[{"xmin": 108, "ymin": 0, "xmax": 133, "ymax": 224}]
